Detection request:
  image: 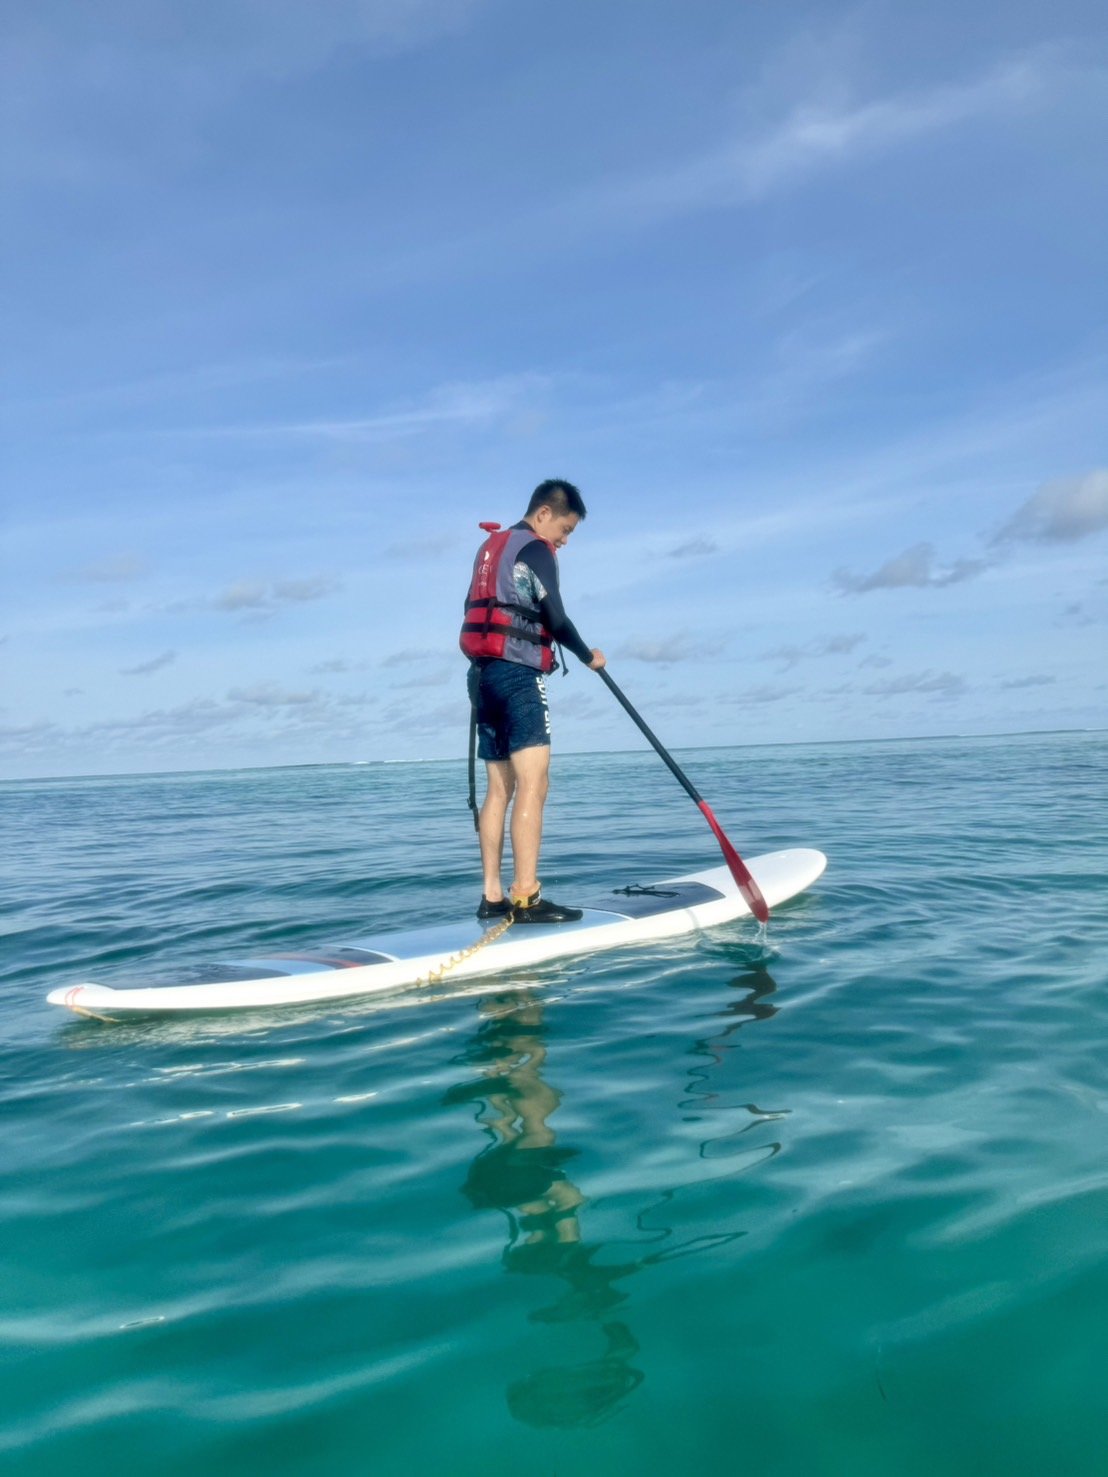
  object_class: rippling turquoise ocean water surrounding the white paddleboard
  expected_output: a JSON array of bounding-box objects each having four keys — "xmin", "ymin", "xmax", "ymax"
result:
[{"xmin": 0, "ymin": 734, "xmax": 1108, "ymax": 1477}]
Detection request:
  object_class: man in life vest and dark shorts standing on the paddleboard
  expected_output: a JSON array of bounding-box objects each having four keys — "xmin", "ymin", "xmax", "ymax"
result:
[{"xmin": 459, "ymin": 480, "xmax": 604, "ymax": 923}]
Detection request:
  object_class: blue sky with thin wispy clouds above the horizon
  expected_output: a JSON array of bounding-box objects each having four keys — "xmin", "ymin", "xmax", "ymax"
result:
[{"xmin": 0, "ymin": 0, "xmax": 1108, "ymax": 778}]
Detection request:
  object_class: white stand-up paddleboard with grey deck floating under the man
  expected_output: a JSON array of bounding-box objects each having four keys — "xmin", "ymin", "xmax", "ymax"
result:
[{"xmin": 47, "ymin": 849, "xmax": 827, "ymax": 1019}]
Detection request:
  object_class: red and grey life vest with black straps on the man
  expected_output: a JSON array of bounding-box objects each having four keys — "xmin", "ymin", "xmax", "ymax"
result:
[{"xmin": 458, "ymin": 523, "xmax": 554, "ymax": 672}]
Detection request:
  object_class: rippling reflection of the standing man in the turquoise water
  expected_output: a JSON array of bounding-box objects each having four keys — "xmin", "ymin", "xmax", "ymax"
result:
[{"xmin": 446, "ymin": 991, "xmax": 643, "ymax": 1425}]
